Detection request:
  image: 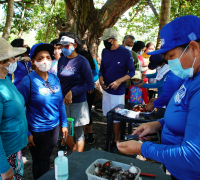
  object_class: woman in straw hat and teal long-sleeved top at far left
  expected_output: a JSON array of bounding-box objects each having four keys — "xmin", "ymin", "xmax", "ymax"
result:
[{"xmin": 0, "ymin": 38, "xmax": 28, "ymax": 180}]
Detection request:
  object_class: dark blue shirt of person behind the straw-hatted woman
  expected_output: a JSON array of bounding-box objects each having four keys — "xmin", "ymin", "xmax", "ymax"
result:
[{"xmin": 8, "ymin": 61, "xmax": 32, "ymax": 88}]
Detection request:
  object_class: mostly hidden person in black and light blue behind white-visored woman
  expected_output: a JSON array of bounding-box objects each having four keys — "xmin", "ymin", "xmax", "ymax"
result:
[{"xmin": 81, "ymin": 40, "xmax": 99, "ymax": 144}]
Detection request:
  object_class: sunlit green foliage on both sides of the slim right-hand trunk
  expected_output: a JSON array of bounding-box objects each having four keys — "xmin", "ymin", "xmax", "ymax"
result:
[{"xmin": 115, "ymin": 0, "xmax": 200, "ymax": 43}]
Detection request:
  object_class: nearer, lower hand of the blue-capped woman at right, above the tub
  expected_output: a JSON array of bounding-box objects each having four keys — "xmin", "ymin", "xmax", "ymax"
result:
[{"xmin": 117, "ymin": 140, "xmax": 142, "ymax": 155}]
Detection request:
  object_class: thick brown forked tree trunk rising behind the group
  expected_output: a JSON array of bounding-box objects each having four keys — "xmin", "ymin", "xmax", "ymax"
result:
[{"xmin": 57, "ymin": 0, "xmax": 140, "ymax": 59}]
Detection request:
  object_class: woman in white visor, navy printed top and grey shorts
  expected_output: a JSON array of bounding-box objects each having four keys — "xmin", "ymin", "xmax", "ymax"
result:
[{"xmin": 58, "ymin": 32, "xmax": 94, "ymax": 152}]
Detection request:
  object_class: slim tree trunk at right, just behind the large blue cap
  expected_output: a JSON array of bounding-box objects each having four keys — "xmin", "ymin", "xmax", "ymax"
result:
[{"xmin": 156, "ymin": 0, "xmax": 171, "ymax": 49}]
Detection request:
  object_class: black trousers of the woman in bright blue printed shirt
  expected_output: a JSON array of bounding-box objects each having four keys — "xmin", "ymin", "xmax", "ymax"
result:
[{"xmin": 29, "ymin": 125, "xmax": 60, "ymax": 179}]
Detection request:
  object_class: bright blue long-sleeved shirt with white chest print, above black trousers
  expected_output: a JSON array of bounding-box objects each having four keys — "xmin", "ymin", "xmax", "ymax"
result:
[{"xmin": 18, "ymin": 71, "xmax": 67, "ymax": 135}]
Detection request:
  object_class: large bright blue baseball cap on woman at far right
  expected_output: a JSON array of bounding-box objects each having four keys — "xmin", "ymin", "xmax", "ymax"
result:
[{"xmin": 147, "ymin": 15, "xmax": 200, "ymax": 55}]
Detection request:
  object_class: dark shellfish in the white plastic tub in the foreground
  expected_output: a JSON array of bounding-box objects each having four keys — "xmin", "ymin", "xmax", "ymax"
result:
[{"xmin": 93, "ymin": 161, "xmax": 138, "ymax": 180}]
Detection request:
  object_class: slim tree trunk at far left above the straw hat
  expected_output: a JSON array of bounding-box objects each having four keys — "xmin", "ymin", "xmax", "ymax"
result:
[{"xmin": 2, "ymin": 0, "xmax": 14, "ymax": 40}]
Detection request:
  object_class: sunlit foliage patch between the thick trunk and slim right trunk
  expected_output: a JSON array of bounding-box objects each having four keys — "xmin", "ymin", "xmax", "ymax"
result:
[{"xmin": 116, "ymin": 0, "xmax": 160, "ymax": 43}]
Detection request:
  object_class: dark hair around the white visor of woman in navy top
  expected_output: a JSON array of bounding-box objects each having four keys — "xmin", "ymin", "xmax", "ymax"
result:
[{"xmin": 59, "ymin": 32, "xmax": 83, "ymax": 54}]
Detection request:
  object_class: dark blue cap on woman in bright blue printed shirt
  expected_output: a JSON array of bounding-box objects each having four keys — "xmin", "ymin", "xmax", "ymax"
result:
[{"xmin": 30, "ymin": 43, "xmax": 54, "ymax": 59}]
